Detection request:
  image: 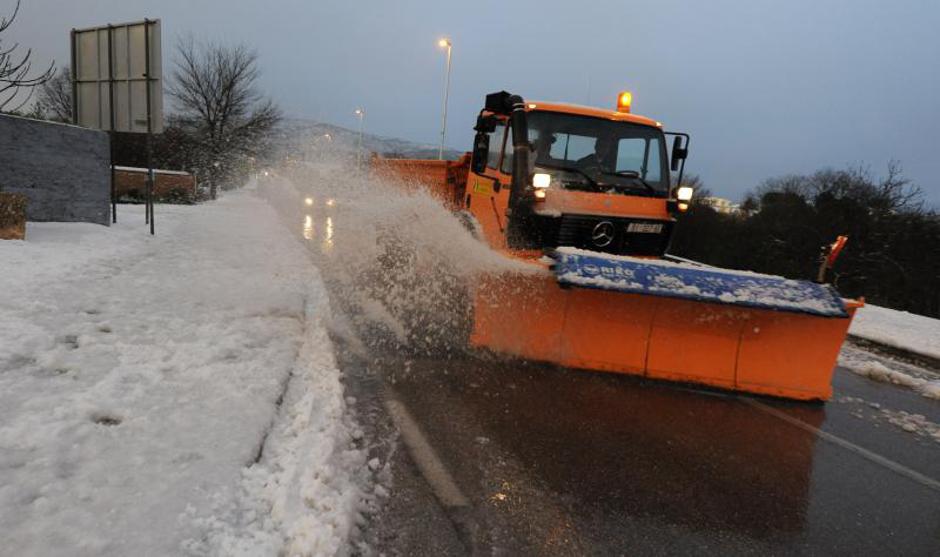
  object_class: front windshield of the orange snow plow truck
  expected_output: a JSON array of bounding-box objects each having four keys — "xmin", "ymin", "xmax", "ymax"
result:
[{"xmin": 528, "ymin": 111, "xmax": 669, "ymax": 195}]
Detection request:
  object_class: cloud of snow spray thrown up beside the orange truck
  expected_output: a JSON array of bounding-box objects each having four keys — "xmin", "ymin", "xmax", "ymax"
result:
[{"xmin": 263, "ymin": 154, "xmax": 531, "ymax": 355}]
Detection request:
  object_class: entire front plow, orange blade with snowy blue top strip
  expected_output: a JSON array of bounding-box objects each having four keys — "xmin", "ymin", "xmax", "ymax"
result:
[{"xmin": 471, "ymin": 248, "xmax": 862, "ymax": 400}]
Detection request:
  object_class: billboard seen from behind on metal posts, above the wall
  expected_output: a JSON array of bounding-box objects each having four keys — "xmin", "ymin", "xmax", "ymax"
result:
[{"xmin": 71, "ymin": 19, "xmax": 163, "ymax": 234}]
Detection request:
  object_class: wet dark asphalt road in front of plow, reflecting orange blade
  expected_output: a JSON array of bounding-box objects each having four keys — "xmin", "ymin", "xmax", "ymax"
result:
[{"xmin": 342, "ymin": 346, "xmax": 940, "ymax": 555}]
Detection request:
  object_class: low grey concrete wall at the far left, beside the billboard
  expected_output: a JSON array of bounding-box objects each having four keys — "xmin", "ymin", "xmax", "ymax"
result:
[{"xmin": 0, "ymin": 114, "xmax": 111, "ymax": 225}]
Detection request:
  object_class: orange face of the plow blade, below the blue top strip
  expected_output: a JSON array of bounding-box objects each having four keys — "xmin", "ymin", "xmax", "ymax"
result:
[{"xmin": 471, "ymin": 252, "xmax": 862, "ymax": 400}]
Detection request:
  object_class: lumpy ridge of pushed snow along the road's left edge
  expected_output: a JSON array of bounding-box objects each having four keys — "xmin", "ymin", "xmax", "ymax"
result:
[{"xmin": 184, "ymin": 276, "xmax": 376, "ymax": 557}]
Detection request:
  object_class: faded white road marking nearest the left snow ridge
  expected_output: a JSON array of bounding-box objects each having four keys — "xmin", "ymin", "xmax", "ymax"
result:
[{"xmin": 385, "ymin": 396, "xmax": 470, "ymax": 508}]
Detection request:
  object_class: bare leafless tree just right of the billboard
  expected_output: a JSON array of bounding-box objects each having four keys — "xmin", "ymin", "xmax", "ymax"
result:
[{"xmin": 168, "ymin": 38, "xmax": 280, "ymax": 199}]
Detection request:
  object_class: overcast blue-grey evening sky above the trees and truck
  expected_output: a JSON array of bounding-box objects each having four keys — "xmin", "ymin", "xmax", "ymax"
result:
[{"xmin": 7, "ymin": 0, "xmax": 940, "ymax": 205}]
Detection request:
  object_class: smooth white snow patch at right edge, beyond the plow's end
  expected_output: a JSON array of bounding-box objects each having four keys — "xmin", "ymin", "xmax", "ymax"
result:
[{"xmin": 849, "ymin": 305, "xmax": 940, "ymax": 360}]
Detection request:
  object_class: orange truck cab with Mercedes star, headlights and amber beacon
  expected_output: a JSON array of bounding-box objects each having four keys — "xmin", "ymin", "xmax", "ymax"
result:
[{"xmin": 464, "ymin": 94, "xmax": 691, "ymax": 257}]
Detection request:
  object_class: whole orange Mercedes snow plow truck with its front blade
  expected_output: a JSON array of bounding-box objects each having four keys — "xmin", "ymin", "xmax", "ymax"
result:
[{"xmin": 373, "ymin": 92, "xmax": 862, "ymax": 400}]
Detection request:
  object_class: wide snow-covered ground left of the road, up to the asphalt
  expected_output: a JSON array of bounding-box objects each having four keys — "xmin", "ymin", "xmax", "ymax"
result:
[{"xmin": 0, "ymin": 193, "xmax": 376, "ymax": 556}]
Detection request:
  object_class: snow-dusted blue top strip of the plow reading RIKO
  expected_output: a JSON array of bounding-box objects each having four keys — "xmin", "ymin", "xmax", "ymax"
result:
[{"xmin": 552, "ymin": 248, "xmax": 848, "ymax": 317}]
